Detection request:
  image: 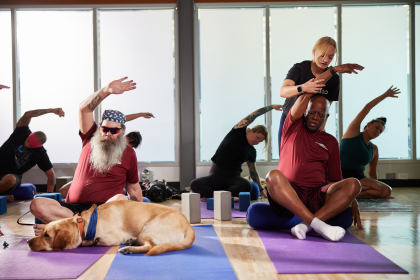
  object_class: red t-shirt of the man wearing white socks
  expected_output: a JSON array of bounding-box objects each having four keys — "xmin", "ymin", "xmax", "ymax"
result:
[{"xmin": 277, "ymin": 112, "xmax": 342, "ymax": 187}]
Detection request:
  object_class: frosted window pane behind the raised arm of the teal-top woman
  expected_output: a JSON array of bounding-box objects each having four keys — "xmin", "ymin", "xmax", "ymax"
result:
[{"xmin": 342, "ymin": 5, "xmax": 411, "ymax": 159}]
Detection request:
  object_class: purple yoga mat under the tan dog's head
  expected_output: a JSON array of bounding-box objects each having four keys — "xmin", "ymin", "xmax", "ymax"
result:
[{"xmin": 0, "ymin": 239, "xmax": 111, "ymax": 279}]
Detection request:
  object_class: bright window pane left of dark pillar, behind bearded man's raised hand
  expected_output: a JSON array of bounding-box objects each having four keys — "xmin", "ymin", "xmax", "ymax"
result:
[{"xmin": 99, "ymin": 9, "xmax": 176, "ymax": 161}]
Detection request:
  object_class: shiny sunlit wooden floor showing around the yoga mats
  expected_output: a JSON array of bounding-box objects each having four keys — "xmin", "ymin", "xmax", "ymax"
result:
[{"xmin": 0, "ymin": 188, "xmax": 420, "ymax": 280}]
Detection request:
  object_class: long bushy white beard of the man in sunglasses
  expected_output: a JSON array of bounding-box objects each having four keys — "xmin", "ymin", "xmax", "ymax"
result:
[{"xmin": 89, "ymin": 129, "xmax": 127, "ymax": 173}]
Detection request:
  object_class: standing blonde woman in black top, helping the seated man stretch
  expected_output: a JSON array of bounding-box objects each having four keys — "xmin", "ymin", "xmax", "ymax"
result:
[{"xmin": 279, "ymin": 37, "xmax": 364, "ymax": 152}]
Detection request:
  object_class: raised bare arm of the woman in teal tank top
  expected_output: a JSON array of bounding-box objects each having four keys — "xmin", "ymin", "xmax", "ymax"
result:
[{"xmin": 343, "ymin": 86, "xmax": 400, "ymax": 139}]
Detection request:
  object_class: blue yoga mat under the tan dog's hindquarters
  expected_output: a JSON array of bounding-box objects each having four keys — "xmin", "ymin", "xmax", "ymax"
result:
[{"xmin": 105, "ymin": 225, "xmax": 236, "ymax": 280}]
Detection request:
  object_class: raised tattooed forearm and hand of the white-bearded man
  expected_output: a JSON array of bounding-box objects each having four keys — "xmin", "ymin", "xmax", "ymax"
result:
[{"xmin": 79, "ymin": 77, "xmax": 136, "ymax": 133}]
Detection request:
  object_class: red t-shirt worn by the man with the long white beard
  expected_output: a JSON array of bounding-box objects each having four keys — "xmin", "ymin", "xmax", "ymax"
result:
[{"xmin": 66, "ymin": 123, "xmax": 139, "ymax": 203}]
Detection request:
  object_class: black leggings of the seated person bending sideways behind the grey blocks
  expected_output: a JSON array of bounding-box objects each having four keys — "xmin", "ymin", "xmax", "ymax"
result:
[{"xmin": 191, "ymin": 164, "xmax": 251, "ymax": 197}]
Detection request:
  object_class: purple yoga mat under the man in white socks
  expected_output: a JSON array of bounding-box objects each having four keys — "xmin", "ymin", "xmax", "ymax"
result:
[{"xmin": 258, "ymin": 230, "xmax": 408, "ymax": 274}]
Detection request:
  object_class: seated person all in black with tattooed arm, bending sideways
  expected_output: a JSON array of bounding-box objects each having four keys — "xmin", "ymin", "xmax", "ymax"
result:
[{"xmin": 191, "ymin": 105, "xmax": 283, "ymax": 198}]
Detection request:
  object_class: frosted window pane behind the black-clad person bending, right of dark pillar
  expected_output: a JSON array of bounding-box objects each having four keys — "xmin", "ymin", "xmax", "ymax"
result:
[{"xmin": 198, "ymin": 8, "xmax": 265, "ymax": 161}]
